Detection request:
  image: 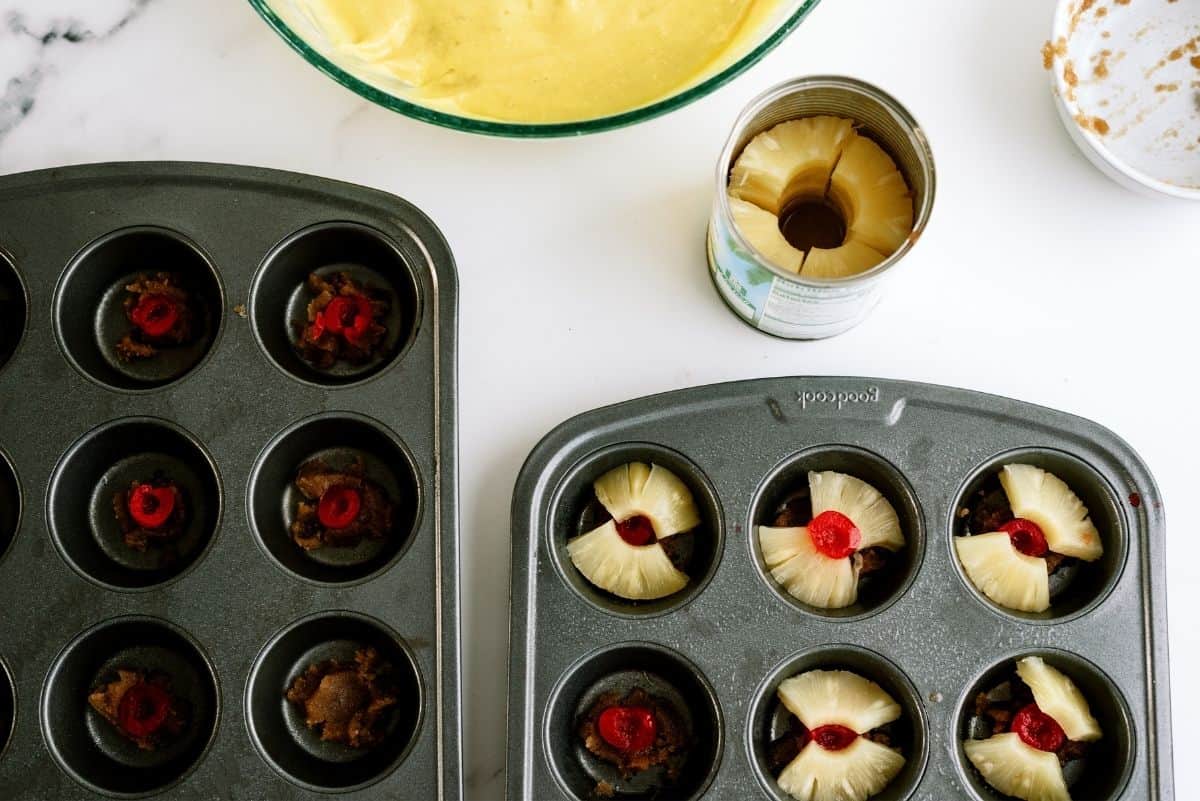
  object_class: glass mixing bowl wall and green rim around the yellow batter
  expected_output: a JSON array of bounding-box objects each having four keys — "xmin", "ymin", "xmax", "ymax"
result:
[{"xmin": 243, "ymin": 0, "xmax": 821, "ymax": 137}]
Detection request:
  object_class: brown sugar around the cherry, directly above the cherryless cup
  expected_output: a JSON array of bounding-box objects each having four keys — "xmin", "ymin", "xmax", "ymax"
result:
[{"xmin": 292, "ymin": 459, "xmax": 395, "ymax": 550}]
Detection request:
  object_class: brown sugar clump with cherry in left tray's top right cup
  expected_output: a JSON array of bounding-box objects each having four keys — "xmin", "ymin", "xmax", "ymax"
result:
[{"xmin": 296, "ymin": 272, "xmax": 391, "ymax": 369}]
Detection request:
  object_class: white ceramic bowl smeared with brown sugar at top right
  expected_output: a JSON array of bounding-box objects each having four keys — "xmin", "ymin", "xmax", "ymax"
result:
[{"xmin": 1045, "ymin": 0, "xmax": 1200, "ymax": 200}]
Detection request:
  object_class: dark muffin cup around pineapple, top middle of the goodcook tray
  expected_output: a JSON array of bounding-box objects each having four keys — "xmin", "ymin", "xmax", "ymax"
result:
[{"xmin": 748, "ymin": 446, "xmax": 925, "ymax": 621}]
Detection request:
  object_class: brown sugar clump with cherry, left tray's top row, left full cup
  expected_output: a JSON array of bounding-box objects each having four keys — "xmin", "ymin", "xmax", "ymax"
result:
[{"xmin": 116, "ymin": 272, "xmax": 196, "ymax": 362}]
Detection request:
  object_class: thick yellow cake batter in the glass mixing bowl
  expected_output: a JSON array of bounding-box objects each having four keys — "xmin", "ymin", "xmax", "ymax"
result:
[{"xmin": 291, "ymin": 0, "xmax": 779, "ymax": 122}]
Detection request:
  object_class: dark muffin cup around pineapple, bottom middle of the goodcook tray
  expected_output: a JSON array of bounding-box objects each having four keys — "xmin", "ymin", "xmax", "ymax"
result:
[{"xmin": 746, "ymin": 645, "xmax": 929, "ymax": 801}]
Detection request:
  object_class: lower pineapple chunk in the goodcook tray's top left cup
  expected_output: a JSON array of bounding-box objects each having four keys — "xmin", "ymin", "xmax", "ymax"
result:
[{"xmin": 566, "ymin": 520, "xmax": 688, "ymax": 601}]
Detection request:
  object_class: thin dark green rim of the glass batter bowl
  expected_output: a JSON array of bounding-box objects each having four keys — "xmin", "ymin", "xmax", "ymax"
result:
[{"xmin": 243, "ymin": 0, "xmax": 821, "ymax": 139}]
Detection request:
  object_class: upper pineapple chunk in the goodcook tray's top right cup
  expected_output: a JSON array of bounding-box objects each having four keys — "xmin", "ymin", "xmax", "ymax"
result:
[{"xmin": 1000, "ymin": 464, "xmax": 1104, "ymax": 562}]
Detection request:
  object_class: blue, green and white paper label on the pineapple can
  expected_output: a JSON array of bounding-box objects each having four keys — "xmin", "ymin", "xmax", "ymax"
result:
[{"xmin": 708, "ymin": 216, "xmax": 880, "ymax": 339}]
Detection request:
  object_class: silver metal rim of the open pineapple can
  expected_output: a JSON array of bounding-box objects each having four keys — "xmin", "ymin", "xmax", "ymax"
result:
[{"xmin": 716, "ymin": 74, "xmax": 937, "ymax": 288}]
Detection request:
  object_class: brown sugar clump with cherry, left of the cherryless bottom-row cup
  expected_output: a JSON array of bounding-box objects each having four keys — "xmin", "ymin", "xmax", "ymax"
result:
[{"xmin": 88, "ymin": 668, "xmax": 188, "ymax": 751}]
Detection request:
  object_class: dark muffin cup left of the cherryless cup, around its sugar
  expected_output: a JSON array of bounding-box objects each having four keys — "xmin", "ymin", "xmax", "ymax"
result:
[{"xmin": 41, "ymin": 616, "xmax": 221, "ymax": 797}]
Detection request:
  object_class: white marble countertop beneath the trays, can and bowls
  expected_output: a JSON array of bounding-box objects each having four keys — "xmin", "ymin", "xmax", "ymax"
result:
[{"xmin": 0, "ymin": 0, "xmax": 1200, "ymax": 799}]
